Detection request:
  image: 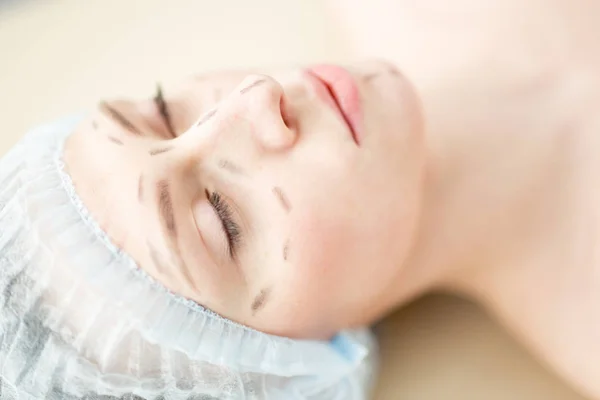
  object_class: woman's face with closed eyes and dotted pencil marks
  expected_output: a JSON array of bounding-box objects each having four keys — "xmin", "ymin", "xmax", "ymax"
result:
[{"xmin": 65, "ymin": 62, "xmax": 424, "ymax": 338}]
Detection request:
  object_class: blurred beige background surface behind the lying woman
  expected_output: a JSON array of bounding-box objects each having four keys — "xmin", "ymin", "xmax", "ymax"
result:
[{"xmin": 0, "ymin": 0, "xmax": 582, "ymax": 400}]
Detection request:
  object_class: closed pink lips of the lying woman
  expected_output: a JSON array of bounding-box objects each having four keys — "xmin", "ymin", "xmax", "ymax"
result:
[{"xmin": 306, "ymin": 64, "xmax": 362, "ymax": 145}]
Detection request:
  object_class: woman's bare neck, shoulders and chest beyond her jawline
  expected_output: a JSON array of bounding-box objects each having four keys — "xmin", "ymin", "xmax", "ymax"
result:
[{"xmin": 329, "ymin": 0, "xmax": 600, "ymax": 399}]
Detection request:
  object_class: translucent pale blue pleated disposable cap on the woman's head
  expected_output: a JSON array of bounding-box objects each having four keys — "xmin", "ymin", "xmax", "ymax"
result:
[{"xmin": 0, "ymin": 117, "xmax": 377, "ymax": 400}]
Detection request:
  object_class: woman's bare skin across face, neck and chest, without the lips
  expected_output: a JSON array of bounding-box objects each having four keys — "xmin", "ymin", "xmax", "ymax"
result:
[{"xmin": 66, "ymin": 0, "xmax": 600, "ymax": 398}]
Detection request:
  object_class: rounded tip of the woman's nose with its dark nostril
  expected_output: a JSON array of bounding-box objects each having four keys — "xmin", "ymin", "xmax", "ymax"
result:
[{"xmin": 233, "ymin": 75, "xmax": 296, "ymax": 151}]
